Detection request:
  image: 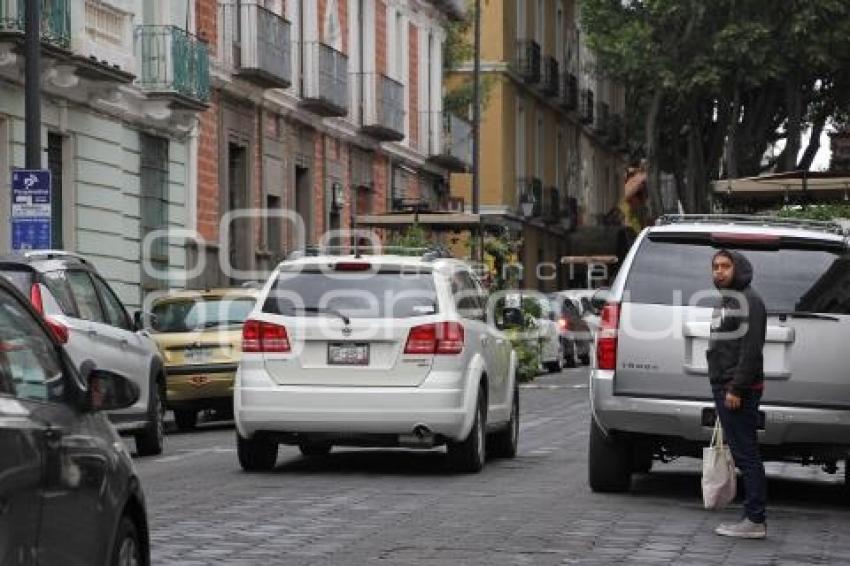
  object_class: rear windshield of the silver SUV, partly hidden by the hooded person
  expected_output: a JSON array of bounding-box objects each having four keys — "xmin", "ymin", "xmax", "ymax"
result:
[{"xmin": 625, "ymin": 238, "xmax": 850, "ymax": 314}]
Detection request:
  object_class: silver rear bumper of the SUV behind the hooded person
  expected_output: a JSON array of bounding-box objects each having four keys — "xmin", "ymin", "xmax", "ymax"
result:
[{"xmin": 590, "ymin": 369, "xmax": 850, "ymax": 447}]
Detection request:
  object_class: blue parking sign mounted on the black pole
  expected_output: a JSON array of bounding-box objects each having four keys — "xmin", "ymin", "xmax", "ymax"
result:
[{"xmin": 12, "ymin": 169, "xmax": 53, "ymax": 251}]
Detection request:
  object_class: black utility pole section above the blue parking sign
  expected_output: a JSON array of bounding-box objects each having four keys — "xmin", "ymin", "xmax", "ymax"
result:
[{"xmin": 24, "ymin": 0, "xmax": 41, "ymax": 169}]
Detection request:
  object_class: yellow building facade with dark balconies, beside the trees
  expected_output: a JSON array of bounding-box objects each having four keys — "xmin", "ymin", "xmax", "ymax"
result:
[{"xmin": 447, "ymin": 0, "xmax": 625, "ymax": 290}]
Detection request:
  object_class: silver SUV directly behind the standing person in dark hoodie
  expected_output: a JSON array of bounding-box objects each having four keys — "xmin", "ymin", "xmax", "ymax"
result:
[{"xmin": 588, "ymin": 215, "xmax": 850, "ymax": 491}]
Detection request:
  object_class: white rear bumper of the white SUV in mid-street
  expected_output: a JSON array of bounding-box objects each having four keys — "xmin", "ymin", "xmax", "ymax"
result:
[{"xmin": 234, "ymin": 367, "xmax": 476, "ymax": 440}]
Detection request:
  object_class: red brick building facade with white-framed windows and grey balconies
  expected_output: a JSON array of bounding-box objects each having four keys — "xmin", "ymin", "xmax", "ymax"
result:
[{"xmin": 190, "ymin": 0, "xmax": 468, "ymax": 286}]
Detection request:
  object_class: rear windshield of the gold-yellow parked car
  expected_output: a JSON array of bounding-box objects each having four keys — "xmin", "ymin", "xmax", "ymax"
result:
[{"xmin": 151, "ymin": 297, "xmax": 254, "ymax": 332}]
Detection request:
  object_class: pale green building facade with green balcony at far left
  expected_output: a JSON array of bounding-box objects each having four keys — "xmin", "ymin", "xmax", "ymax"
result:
[{"xmin": 0, "ymin": 0, "xmax": 209, "ymax": 307}]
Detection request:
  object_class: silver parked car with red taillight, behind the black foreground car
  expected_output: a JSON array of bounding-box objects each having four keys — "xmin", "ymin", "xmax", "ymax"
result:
[{"xmin": 0, "ymin": 251, "xmax": 165, "ymax": 456}]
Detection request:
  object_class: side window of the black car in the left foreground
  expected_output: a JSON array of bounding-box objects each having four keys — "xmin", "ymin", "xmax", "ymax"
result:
[{"xmin": 0, "ymin": 291, "xmax": 64, "ymax": 401}]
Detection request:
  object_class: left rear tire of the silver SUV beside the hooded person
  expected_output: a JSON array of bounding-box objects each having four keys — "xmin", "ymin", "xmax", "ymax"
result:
[{"xmin": 587, "ymin": 417, "xmax": 633, "ymax": 493}]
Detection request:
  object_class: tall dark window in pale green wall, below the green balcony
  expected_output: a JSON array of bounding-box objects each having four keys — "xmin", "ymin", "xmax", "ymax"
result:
[{"xmin": 140, "ymin": 134, "xmax": 168, "ymax": 290}]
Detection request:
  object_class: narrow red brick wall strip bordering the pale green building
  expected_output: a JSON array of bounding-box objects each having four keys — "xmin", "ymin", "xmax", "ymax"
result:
[{"xmin": 197, "ymin": 92, "xmax": 220, "ymax": 241}]
